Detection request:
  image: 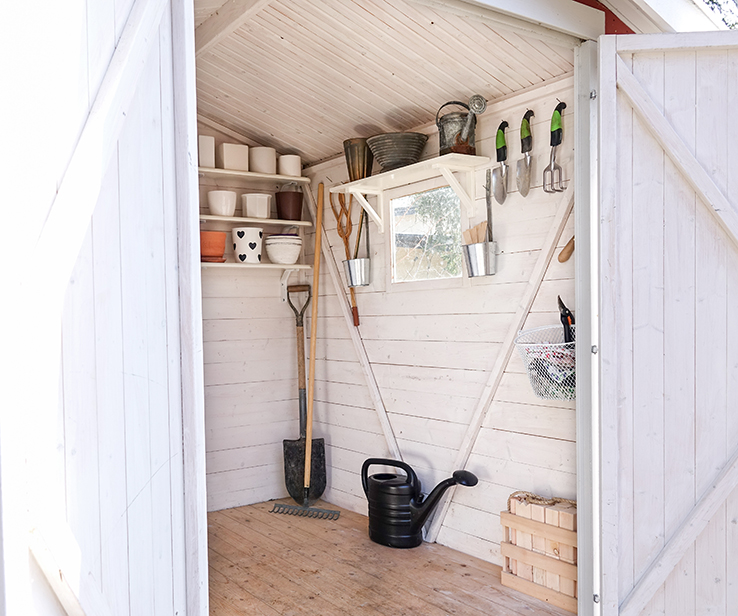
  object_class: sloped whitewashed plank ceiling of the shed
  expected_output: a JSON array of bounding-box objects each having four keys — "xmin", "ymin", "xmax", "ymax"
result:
[{"xmin": 195, "ymin": 0, "xmax": 573, "ymax": 164}]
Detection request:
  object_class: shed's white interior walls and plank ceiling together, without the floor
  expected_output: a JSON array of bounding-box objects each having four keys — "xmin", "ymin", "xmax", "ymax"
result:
[{"xmin": 195, "ymin": 0, "xmax": 576, "ymax": 608}]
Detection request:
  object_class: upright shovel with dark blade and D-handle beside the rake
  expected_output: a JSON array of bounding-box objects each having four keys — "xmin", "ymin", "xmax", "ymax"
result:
[{"xmin": 282, "ymin": 284, "xmax": 326, "ymax": 504}]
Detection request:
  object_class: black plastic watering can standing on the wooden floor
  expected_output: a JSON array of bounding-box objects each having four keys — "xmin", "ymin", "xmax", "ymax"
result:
[{"xmin": 361, "ymin": 458, "xmax": 478, "ymax": 548}]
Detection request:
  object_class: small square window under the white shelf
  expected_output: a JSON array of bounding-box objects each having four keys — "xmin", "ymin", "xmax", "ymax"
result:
[{"xmin": 390, "ymin": 186, "xmax": 461, "ymax": 282}]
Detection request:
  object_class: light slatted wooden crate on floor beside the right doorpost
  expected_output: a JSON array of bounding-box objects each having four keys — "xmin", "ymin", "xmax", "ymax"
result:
[{"xmin": 500, "ymin": 498, "xmax": 577, "ymax": 614}]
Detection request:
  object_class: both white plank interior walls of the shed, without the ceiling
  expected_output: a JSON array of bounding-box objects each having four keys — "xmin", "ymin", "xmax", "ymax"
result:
[{"xmin": 200, "ymin": 77, "xmax": 576, "ymax": 562}]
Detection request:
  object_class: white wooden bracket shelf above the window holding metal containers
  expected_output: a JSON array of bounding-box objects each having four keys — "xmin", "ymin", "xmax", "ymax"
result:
[{"xmin": 330, "ymin": 154, "xmax": 490, "ymax": 233}]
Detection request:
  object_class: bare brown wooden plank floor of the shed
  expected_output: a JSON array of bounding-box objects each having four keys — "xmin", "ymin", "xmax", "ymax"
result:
[{"xmin": 208, "ymin": 500, "xmax": 571, "ymax": 616}]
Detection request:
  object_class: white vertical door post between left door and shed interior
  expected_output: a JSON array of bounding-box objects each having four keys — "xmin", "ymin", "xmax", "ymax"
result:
[{"xmin": 172, "ymin": 0, "xmax": 209, "ymax": 616}]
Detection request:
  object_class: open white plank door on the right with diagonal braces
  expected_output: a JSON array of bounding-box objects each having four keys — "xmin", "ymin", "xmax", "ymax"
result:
[{"xmin": 598, "ymin": 32, "xmax": 738, "ymax": 616}]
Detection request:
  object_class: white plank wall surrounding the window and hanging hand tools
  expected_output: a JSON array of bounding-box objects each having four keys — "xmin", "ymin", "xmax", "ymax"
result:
[{"xmin": 307, "ymin": 78, "xmax": 576, "ymax": 562}]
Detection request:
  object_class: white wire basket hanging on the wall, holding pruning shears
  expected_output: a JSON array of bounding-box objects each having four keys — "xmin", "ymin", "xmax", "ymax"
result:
[{"xmin": 515, "ymin": 325, "xmax": 577, "ymax": 400}]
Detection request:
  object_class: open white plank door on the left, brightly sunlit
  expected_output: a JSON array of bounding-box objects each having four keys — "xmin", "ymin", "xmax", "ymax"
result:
[{"xmin": 0, "ymin": 0, "xmax": 201, "ymax": 616}]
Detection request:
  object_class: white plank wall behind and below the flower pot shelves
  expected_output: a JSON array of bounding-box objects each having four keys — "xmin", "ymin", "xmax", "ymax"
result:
[{"xmin": 198, "ymin": 124, "xmax": 310, "ymax": 511}]
